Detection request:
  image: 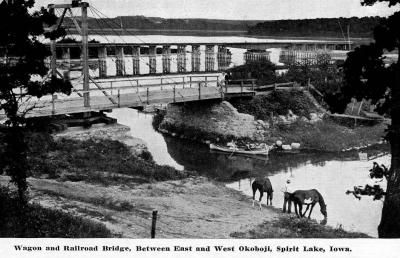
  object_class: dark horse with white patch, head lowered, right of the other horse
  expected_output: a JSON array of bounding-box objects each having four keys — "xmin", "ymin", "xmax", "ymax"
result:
[{"xmin": 285, "ymin": 189, "xmax": 328, "ymax": 220}]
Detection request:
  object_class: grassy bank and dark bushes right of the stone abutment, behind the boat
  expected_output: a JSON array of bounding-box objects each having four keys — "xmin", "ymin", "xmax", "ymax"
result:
[{"xmin": 232, "ymin": 90, "xmax": 386, "ymax": 152}]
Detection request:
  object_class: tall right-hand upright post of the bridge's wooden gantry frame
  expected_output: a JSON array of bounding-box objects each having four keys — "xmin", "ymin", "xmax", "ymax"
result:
[{"xmin": 81, "ymin": 2, "xmax": 90, "ymax": 107}]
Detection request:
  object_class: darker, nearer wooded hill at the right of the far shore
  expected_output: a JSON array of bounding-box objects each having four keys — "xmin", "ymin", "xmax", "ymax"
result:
[{"xmin": 248, "ymin": 17, "xmax": 384, "ymax": 38}]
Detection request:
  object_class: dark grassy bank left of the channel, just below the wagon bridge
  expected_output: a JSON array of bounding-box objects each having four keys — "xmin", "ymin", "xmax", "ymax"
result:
[{"xmin": 30, "ymin": 135, "xmax": 191, "ymax": 184}]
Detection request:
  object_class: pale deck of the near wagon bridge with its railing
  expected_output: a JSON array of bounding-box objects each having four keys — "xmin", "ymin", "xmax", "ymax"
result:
[{"xmin": 20, "ymin": 87, "xmax": 255, "ymax": 117}]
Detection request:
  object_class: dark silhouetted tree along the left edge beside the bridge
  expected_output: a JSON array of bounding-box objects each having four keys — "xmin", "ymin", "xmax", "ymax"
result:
[{"xmin": 0, "ymin": 0, "xmax": 72, "ymax": 203}]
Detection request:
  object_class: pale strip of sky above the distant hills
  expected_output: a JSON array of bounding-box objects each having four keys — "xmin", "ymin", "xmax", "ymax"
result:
[{"xmin": 36, "ymin": 0, "xmax": 400, "ymax": 20}]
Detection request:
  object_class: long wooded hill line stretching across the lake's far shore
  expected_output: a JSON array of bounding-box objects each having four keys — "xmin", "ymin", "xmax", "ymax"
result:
[{"xmin": 64, "ymin": 16, "xmax": 384, "ymax": 38}]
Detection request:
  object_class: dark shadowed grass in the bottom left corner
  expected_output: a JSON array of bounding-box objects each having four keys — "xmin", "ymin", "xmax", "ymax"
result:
[{"xmin": 0, "ymin": 188, "xmax": 112, "ymax": 238}]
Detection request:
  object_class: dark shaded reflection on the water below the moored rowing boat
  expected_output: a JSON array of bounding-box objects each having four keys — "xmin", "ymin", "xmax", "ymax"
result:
[{"xmin": 164, "ymin": 136, "xmax": 376, "ymax": 182}]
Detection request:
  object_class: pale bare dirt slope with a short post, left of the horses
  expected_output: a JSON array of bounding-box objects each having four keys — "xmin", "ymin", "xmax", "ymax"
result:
[{"xmin": 0, "ymin": 177, "xmax": 278, "ymax": 238}]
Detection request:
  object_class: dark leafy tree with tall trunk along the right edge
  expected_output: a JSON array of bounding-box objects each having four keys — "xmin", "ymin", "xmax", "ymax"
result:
[{"xmin": 342, "ymin": 0, "xmax": 400, "ymax": 238}]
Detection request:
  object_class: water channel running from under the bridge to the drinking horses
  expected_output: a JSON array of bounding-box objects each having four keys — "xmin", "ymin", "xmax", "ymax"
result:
[{"xmin": 111, "ymin": 109, "xmax": 390, "ymax": 237}]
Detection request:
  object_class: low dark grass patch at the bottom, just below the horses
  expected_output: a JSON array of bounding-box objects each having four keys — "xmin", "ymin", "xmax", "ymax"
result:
[{"xmin": 230, "ymin": 216, "xmax": 368, "ymax": 239}]
